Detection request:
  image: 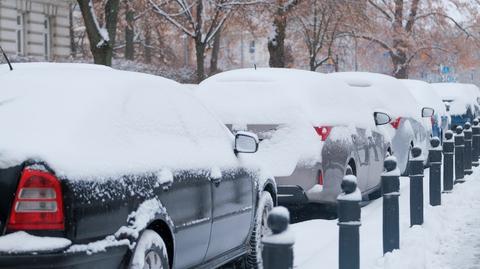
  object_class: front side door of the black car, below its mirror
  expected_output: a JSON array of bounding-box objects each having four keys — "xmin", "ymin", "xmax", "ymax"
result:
[{"xmin": 205, "ymin": 170, "xmax": 255, "ymax": 261}]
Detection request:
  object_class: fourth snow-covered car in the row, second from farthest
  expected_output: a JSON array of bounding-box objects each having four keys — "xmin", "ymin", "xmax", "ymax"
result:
[{"xmin": 402, "ymin": 79, "xmax": 450, "ymax": 141}]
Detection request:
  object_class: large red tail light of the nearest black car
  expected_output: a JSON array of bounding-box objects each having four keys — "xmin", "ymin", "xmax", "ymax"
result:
[{"xmin": 7, "ymin": 168, "xmax": 65, "ymax": 230}]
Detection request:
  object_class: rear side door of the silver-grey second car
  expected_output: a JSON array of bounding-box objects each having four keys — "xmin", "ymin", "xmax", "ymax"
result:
[{"xmin": 352, "ymin": 128, "xmax": 371, "ymax": 191}]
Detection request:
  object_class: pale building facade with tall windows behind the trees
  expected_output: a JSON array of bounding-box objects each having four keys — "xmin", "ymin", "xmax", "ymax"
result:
[{"xmin": 0, "ymin": 0, "xmax": 71, "ymax": 61}]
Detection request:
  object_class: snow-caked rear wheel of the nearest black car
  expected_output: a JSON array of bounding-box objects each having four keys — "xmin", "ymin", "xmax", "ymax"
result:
[{"xmin": 129, "ymin": 229, "xmax": 170, "ymax": 269}]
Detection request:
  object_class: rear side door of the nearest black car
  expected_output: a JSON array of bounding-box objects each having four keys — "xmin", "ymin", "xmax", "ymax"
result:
[{"xmin": 159, "ymin": 173, "xmax": 212, "ymax": 268}]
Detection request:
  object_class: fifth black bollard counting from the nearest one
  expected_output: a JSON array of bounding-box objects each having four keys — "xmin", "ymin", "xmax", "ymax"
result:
[{"xmin": 428, "ymin": 137, "xmax": 442, "ymax": 206}]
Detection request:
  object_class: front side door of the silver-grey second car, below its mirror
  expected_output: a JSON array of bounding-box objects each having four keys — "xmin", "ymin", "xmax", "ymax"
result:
[{"xmin": 368, "ymin": 130, "xmax": 386, "ymax": 189}]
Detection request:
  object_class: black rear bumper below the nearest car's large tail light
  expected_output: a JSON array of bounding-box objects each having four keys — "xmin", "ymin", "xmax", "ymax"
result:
[{"xmin": 0, "ymin": 246, "xmax": 128, "ymax": 269}]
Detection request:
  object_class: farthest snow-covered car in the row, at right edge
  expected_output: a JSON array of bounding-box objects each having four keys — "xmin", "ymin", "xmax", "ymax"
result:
[{"xmin": 431, "ymin": 83, "xmax": 480, "ymax": 130}]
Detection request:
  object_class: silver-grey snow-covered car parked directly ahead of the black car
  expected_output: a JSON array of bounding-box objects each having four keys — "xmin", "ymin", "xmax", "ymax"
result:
[{"xmin": 197, "ymin": 68, "xmax": 390, "ymax": 205}]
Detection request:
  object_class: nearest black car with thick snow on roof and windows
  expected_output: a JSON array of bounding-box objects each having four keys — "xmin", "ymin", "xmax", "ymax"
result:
[{"xmin": 0, "ymin": 63, "xmax": 276, "ymax": 268}]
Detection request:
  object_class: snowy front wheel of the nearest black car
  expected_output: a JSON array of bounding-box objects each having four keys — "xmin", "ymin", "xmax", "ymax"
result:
[{"xmin": 245, "ymin": 191, "xmax": 273, "ymax": 269}]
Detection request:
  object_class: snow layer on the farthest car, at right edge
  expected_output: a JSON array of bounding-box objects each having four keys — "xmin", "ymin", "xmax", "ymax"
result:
[{"xmin": 431, "ymin": 83, "xmax": 480, "ymax": 115}]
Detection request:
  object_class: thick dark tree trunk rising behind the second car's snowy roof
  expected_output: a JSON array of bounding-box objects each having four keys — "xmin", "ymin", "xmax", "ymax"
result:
[{"xmin": 268, "ymin": 8, "xmax": 287, "ymax": 67}]
